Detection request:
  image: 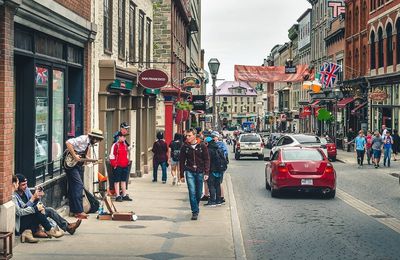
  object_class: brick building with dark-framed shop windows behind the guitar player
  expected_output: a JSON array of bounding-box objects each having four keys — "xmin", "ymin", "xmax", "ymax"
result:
[{"xmin": 0, "ymin": 0, "xmax": 96, "ymax": 236}]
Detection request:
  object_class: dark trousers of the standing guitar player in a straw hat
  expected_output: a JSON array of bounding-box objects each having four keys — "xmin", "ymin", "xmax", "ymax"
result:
[{"xmin": 66, "ymin": 166, "xmax": 83, "ymax": 213}]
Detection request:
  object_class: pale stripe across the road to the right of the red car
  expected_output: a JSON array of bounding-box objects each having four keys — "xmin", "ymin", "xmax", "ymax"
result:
[{"xmin": 336, "ymin": 189, "xmax": 400, "ymax": 233}]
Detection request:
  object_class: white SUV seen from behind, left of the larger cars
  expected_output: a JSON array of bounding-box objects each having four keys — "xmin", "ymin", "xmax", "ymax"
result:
[{"xmin": 235, "ymin": 133, "xmax": 264, "ymax": 160}]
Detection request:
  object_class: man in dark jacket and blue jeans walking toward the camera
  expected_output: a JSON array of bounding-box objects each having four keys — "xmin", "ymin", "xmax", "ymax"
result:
[{"xmin": 179, "ymin": 129, "xmax": 210, "ymax": 220}]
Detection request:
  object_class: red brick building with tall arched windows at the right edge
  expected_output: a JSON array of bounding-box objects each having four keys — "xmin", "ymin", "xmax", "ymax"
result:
[{"xmin": 366, "ymin": 0, "xmax": 400, "ymax": 130}]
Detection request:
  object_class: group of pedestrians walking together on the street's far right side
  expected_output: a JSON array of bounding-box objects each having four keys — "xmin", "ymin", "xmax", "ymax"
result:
[{"xmin": 347, "ymin": 125, "xmax": 400, "ymax": 168}]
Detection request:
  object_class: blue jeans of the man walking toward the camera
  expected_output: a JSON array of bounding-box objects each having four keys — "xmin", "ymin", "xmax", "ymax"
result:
[{"xmin": 185, "ymin": 171, "xmax": 204, "ymax": 214}]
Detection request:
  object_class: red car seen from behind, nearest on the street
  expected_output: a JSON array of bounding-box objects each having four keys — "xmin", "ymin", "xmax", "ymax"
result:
[{"xmin": 265, "ymin": 147, "xmax": 336, "ymax": 198}]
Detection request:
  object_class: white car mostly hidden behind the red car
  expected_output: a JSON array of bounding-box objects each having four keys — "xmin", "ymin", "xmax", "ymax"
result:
[{"xmin": 270, "ymin": 134, "xmax": 328, "ymax": 157}]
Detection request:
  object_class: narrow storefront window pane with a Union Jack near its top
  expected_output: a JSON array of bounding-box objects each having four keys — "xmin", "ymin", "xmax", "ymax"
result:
[{"xmin": 35, "ymin": 67, "xmax": 49, "ymax": 176}]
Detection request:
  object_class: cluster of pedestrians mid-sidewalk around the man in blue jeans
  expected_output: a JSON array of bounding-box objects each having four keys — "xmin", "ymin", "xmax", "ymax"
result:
[{"xmin": 152, "ymin": 129, "xmax": 229, "ymax": 220}]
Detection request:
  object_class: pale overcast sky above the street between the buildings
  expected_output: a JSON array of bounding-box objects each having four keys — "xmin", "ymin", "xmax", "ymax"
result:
[{"xmin": 201, "ymin": 0, "xmax": 311, "ymax": 92}]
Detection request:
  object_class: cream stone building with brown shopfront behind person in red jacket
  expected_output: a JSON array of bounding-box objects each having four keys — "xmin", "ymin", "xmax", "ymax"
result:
[{"xmin": 94, "ymin": 0, "xmax": 157, "ymax": 178}]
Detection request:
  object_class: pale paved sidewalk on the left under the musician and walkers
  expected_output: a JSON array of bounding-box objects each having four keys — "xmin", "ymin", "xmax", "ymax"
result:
[{"xmin": 14, "ymin": 174, "xmax": 245, "ymax": 259}]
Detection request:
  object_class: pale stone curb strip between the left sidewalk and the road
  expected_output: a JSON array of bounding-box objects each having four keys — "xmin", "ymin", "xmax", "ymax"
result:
[{"xmin": 225, "ymin": 174, "xmax": 247, "ymax": 259}]
